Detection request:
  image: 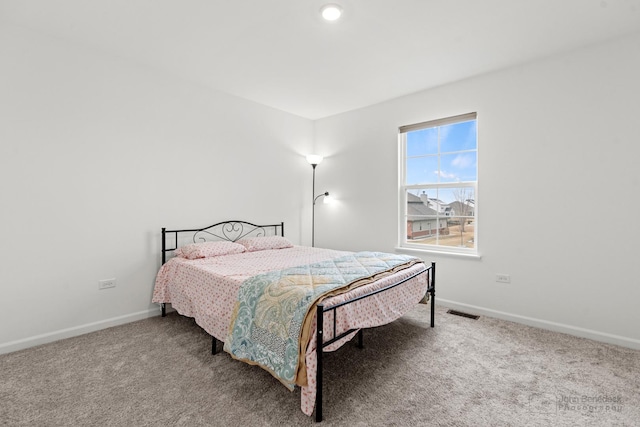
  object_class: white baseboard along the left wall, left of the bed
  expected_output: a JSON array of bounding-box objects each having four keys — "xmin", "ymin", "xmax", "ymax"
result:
[{"xmin": 0, "ymin": 308, "xmax": 160, "ymax": 354}]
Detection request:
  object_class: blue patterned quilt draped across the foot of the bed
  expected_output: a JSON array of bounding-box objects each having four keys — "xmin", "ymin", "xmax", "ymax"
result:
[{"xmin": 224, "ymin": 252, "xmax": 419, "ymax": 389}]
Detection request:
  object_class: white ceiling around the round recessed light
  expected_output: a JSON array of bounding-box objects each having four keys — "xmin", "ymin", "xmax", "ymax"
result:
[{"xmin": 0, "ymin": 0, "xmax": 640, "ymax": 119}]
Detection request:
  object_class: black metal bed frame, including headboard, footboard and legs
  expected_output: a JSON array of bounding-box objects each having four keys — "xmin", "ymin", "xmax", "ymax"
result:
[{"xmin": 160, "ymin": 221, "xmax": 436, "ymax": 422}]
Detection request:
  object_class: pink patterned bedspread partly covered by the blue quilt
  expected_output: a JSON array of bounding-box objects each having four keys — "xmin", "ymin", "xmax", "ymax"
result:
[{"xmin": 152, "ymin": 246, "xmax": 428, "ymax": 415}]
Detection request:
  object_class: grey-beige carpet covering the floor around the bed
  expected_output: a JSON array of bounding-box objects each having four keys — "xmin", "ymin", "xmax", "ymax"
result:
[{"xmin": 0, "ymin": 305, "xmax": 640, "ymax": 426}]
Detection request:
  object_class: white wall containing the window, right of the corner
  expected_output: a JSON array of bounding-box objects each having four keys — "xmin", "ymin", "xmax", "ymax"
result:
[{"xmin": 316, "ymin": 35, "xmax": 640, "ymax": 348}]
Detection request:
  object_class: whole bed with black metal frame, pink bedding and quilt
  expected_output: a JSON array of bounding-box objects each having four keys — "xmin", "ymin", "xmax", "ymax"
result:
[{"xmin": 152, "ymin": 221, "xmax": 435, "ymax": 421}]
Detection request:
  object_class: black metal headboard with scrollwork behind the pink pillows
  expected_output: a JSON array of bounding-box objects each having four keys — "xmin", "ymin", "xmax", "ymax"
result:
[{"xmin": 162, "ymin": 221, "xmax": 284, "ymax": 264}]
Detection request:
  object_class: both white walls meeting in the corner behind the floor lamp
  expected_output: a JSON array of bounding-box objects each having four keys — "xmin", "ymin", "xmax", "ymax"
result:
[{"xmin": 0, "ymin": 20, "xmax": 640, "ymax": 353}]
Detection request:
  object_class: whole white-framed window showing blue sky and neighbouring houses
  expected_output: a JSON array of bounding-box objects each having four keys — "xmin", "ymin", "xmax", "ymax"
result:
[{"xmin": 399, "ymin": 113, "xmax": 478, "ymax": 254}]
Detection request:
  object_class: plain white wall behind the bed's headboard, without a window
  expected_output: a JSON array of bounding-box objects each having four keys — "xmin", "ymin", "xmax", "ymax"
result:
[{"xmin": 0, "ymin": 24, "xmax": 313, "ymax": 352}]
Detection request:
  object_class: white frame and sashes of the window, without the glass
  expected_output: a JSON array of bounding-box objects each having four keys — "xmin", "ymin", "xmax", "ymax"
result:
[{"xmin": 398, "ymin": 113, "xmax": 479, "ymax": 256}]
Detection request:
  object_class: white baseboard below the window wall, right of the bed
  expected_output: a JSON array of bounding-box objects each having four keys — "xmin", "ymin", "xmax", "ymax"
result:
[{"xmin": 436, "ymin": 298, "xmax": 640, "ymax": 350}]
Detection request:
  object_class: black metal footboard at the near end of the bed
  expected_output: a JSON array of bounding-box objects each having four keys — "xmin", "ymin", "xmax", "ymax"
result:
[{"xmin": 315, "ymin": 262, "xmax": 436, "ymax": 422}]
